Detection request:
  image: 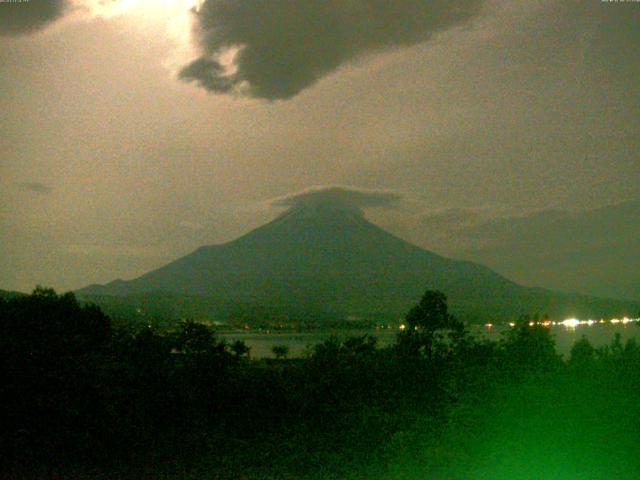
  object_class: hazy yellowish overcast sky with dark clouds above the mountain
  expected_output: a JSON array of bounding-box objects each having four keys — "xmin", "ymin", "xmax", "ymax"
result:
[{"xmin": 0, "ymin": 0, "xmax": 640, "ymax": 291}]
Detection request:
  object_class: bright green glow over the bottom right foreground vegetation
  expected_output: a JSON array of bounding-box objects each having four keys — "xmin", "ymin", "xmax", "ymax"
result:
[{"xmin": 389, "ymin": 377, "xmax": 640, "ymax": 480}]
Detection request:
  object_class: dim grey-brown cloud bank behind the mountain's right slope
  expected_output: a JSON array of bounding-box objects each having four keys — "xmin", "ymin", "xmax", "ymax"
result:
[{"xmin": 451, "ymin": 200, "xmax": 640, "ymax": 300}]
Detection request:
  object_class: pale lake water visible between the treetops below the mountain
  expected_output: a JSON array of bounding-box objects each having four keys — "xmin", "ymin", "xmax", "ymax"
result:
[{"xmin": 220, "ymin": 323, "xmax": 640, "ymax": 358}]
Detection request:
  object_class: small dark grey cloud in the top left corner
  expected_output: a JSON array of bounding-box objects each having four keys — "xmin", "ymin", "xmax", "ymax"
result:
[{"xmin": 0, "ymin": 0, "xmax": 69, "ymax": 35}]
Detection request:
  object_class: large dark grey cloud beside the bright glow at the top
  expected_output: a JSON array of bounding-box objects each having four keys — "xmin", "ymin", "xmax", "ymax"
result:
[{"xmin": 179, "ymin": 0, "xmax": 484, "ymax": 100}]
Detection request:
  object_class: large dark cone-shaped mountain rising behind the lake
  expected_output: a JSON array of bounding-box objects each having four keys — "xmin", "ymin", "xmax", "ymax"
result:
[{"xmin": 78, "ymin": 202, "xmax": 633, "ymax": 320}]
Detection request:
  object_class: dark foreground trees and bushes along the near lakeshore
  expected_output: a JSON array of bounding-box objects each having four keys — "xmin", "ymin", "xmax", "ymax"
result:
[{"xmin": 0, "ymin": 289, "xmax": 640, "ymax": 480}]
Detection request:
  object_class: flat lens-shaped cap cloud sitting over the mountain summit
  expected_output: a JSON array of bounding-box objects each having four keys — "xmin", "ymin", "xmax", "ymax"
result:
[{"xmin": 270, "ymin": 185, "xmax": 402, "ymax": 210}]
